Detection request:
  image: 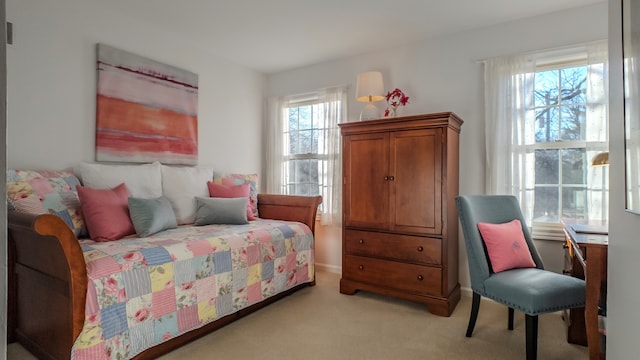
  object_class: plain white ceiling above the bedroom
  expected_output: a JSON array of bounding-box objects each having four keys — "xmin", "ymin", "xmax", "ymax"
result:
[{"xmin": 109, "ymin": 0, "xmax": 606, "ymax": 74}]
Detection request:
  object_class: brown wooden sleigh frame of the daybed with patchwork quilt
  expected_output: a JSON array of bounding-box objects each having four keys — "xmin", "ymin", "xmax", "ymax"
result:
[{"xmin": 7, "ymin": 194, "xmax": 322, "ymax": 359}]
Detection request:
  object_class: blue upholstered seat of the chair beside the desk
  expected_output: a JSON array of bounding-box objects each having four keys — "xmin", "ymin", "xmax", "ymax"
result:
[{"xmin": 484, "ymin": 268, "xmax": 585, "ymax": 315}]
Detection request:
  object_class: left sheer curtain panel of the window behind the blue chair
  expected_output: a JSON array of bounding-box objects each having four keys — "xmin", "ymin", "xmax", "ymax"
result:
[{"xmin": 484, "ymin": 51, "xmax": 535, "ymax": 219}]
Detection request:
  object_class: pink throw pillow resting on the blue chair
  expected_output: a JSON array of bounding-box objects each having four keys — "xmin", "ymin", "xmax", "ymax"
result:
[{"xmin": 478, "ymin": 219, "xmax": 536, "ymax": 273}]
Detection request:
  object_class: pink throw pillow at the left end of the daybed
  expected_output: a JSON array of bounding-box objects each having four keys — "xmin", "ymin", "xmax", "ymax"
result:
[{"xmin": 76, "ymin": 183, "xmax": 136, "ymax": 241}]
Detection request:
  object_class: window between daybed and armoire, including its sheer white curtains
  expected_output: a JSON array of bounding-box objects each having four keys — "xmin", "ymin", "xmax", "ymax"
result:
[{"xmin": 265, "ymin": 87, "xmax": 347, "ymax": 225}]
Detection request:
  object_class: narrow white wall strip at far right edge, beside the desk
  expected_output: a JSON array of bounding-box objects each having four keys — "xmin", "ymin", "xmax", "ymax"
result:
[{"xmin": 607, "ymin": 0, "xmax": 640, "ymax": 359}]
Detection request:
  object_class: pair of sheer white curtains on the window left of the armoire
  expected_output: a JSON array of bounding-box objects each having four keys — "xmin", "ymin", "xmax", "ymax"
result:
[{"xmin": 265, "ymin": 86, "xmax": 347, "ymax": 225}]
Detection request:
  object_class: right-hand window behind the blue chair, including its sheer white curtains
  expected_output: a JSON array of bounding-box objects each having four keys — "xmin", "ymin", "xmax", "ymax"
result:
[{"xmin": 484, "ymin": 42, "xmax": 609, "ymax": 240}]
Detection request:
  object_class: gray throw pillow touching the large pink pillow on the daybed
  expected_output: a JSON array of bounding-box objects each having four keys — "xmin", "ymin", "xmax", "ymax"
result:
[{"xmin": 129, "ymin": 196, "xmax": 178, "ymax": 237}]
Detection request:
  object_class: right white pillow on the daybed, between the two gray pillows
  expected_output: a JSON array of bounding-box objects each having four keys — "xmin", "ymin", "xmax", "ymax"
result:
[{"xmin": 162, "ymin": 165, "xmax": 213, "ymax": 225}]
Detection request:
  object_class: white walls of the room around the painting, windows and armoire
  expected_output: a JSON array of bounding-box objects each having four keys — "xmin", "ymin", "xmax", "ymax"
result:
[{"xmin": 7, "ymin": 0, "xmax": 640, "ymax": 359}]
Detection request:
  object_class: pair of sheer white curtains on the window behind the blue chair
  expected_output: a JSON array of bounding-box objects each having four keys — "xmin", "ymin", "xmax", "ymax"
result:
[{"xmin": 484, "ymin": 41, "xmax": 608, "ymax": 224}]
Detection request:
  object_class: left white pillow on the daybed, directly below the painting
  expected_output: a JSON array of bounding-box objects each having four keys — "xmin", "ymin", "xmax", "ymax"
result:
[{"xmin": 76, "ymin": 161, "xmax": 162, "ymax": 199}]
